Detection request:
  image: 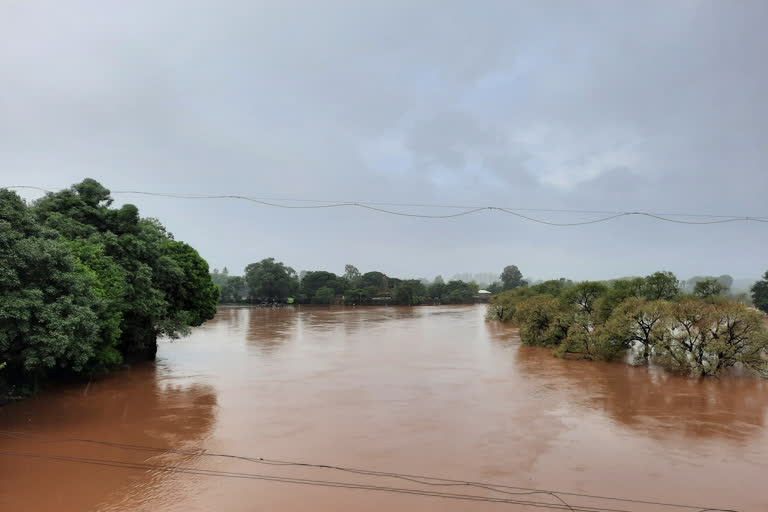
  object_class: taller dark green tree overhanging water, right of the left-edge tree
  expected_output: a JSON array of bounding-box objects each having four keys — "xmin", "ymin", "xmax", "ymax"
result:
[{"xmin": 33, "ymin": 179, "xmax": 217, "ymax": 359}]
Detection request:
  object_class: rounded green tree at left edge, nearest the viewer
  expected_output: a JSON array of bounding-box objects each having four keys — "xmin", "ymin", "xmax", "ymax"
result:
[{"xmin": 0, "ymin": 189, "xmax": 104, "ymax": 398}]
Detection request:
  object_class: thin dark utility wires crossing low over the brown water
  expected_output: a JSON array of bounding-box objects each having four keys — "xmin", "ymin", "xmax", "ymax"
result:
[{"xmin": 0, "ymin": 430, "xmax": 739, "ymax": 512}]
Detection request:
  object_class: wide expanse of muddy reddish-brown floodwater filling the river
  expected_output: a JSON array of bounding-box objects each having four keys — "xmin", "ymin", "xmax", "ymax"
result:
[{"xmin": 0, "ymin": 306, "xmax": 768, "ymax": 512}]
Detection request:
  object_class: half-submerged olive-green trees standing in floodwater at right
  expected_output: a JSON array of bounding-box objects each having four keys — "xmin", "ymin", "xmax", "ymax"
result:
[{"xmin": 488, "ymin": 272, "xmax": 768, "ymax": 376}]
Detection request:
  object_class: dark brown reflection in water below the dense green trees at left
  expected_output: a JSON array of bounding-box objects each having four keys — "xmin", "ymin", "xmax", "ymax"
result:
[{"xmin": 0, "ymin": 364, "xmax": 217, "ymax": 511}]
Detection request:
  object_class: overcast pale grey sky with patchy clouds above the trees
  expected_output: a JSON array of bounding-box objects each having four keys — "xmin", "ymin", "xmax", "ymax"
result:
[{"xmin": 0, "ymin": 0, "xmax": 768, "ymax": 279}]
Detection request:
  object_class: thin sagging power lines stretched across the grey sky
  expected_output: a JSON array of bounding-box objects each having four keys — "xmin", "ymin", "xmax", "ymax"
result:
[{"xmin": 6, "ymin": 185, "xmax": 768, "ymax": 227}]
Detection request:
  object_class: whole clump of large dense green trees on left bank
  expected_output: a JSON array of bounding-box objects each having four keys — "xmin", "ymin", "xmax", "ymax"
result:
[{"xmin": 0, "ymin": 179, "xmax": 219, "ymax": 400}]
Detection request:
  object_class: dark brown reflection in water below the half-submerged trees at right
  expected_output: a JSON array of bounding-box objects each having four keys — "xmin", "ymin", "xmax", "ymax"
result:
[{"xmin": 488, "ymin": 323, "xmax": 768, "ymax": 442}]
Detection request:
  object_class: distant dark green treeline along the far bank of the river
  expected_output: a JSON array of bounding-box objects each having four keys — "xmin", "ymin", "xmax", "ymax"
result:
[{"xmin": 211, "ymin": 264, "xmax": 526, "ymax": 306}]
